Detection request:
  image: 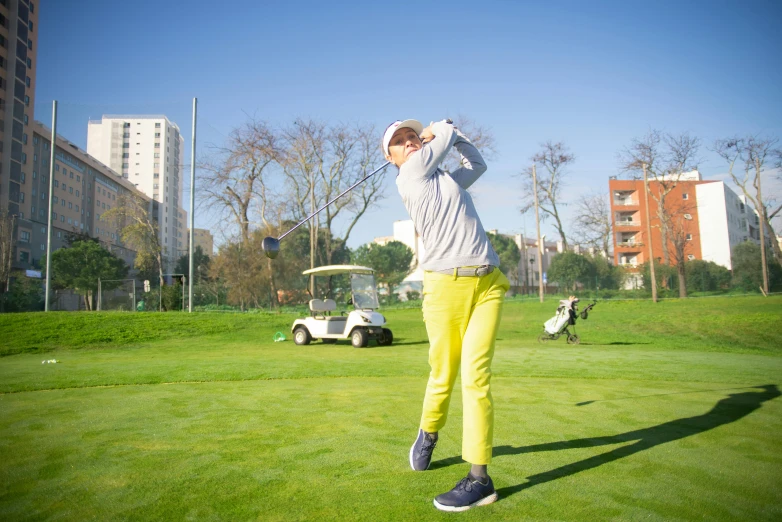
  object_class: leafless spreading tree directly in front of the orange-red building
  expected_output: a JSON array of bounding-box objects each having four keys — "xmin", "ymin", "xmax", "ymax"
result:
[{"xmin": 620, "ymin": 129, "xmax": 700, "ymax": 265}]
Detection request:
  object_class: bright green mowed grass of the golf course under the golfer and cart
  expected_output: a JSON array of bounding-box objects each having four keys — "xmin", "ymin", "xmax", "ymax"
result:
[{"xmin": 0, "ymin": 296, "xmax": 782, "ymax": 521}]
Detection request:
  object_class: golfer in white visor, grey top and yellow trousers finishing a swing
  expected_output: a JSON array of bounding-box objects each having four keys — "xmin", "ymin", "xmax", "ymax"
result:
[{"xmin": 383, "ymin": 120, "xmax": 510, "ymax": 511}]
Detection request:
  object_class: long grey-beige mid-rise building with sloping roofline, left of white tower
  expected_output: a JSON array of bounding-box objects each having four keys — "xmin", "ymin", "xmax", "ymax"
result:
[{"xmin": 13, "ymin": 122, "xmax": 158, "ymax": 270}]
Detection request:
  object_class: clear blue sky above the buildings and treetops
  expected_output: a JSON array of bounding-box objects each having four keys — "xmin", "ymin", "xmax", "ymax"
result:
[{"xmin": 35, "ymin": 0, "xmax": 782, "ymax": 248}]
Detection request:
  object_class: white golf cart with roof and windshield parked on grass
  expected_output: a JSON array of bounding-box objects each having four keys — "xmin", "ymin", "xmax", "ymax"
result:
[{"xmin": 291, "ymin": 265, "xmax": 394, "ymax": 348}]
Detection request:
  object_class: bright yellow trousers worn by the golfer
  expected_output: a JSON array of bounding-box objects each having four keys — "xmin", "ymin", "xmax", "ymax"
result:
[{"xmin": 420, "ymin": 269, "xmax": 510, "ymax": 464}]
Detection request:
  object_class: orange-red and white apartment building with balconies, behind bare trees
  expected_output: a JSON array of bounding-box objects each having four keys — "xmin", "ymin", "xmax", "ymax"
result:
[{"xmin": 608, "ymin": 171, "xmax": 759, "ymax": 269}]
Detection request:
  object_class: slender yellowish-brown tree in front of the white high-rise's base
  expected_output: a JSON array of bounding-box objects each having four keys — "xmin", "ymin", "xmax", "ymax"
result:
[{"xmin": 100, "ymin": 193, "xmax": 163, "ymax": 287}]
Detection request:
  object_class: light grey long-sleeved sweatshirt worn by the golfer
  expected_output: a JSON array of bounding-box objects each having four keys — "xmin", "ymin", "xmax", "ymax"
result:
[{"xmin": 396, "ymin": 121, "xmax": 500, "ymax": 271}]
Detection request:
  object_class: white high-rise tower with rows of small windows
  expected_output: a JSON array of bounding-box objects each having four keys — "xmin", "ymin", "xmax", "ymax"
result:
[{"xmin": 87, "ymin": 115, "xmax": 187, "ymax": 264}]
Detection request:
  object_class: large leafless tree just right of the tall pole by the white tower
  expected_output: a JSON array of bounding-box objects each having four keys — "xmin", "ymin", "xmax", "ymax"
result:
[{"xmin": 199, "ymin": 118, "xmax": 279, "ymax": 242}]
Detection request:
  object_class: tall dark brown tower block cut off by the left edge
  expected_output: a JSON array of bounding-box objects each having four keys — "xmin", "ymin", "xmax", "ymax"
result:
[{"xmin": 0, "ymin": 0, "xmax": 38, "ymax": 218}]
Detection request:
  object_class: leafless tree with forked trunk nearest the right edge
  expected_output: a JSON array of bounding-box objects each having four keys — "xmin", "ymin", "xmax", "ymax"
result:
[{"xmin": 714, "ymin": 136, "xmax": 782, "ymax": 292}]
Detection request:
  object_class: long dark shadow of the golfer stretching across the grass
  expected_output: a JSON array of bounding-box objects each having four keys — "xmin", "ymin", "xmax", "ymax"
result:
[{"xmin": 432, "ymin": 384, "xmax": 782, "ymax": 497}]
